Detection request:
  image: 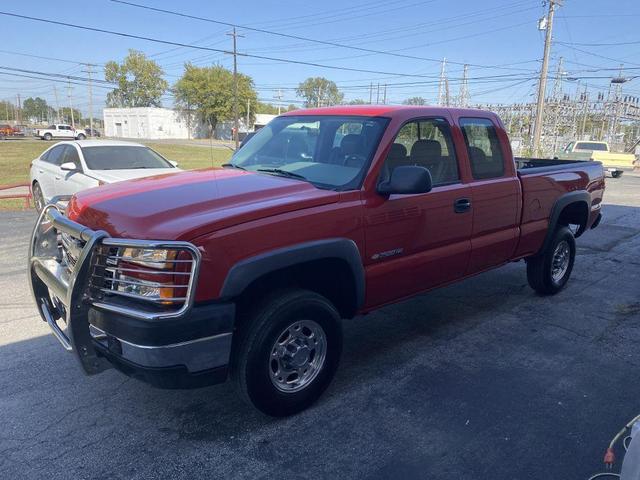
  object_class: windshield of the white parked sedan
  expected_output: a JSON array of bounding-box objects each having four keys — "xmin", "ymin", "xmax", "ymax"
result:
[{"xmin": 82, "ymin": 145, "xmax": 174, "ymax": 170}]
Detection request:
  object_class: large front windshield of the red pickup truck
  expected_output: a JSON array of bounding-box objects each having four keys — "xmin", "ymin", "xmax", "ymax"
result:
[{"xmin": 230, "ymin": 115, "xmax": 388, "ymax": 190}]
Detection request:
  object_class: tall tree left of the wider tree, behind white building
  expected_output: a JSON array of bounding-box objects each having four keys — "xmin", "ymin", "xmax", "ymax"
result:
[{"xmin": 104, "ymin": 50, "xmax": 169, "ymax": 107}]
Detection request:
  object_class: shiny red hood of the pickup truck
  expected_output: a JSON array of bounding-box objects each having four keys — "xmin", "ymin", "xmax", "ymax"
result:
[{"xmin": 67, "ymin": 168, "xmax": 339, "ymax": 240}]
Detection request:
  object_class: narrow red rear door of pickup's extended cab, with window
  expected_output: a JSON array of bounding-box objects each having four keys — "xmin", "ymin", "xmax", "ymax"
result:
[{"xmin": 459, "ymin": 118, "xmax": 522, "ymax": 273}]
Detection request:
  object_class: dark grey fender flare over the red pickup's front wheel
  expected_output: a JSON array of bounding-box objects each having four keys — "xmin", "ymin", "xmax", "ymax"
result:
[{"xmin": 220, "ymin": 238, "xmax": 365, "ymax": 308}]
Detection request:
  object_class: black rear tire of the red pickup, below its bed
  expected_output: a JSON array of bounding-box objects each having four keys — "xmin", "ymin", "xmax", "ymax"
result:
[{"xmin": 527, "ymin": 226, "xmax": 576, "ymax": 295}]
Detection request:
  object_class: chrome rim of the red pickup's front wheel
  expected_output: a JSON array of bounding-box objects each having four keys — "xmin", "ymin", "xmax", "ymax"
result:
[{"xmin": 268, "ymin": 320, "xmax": 327, "ymax": 393}]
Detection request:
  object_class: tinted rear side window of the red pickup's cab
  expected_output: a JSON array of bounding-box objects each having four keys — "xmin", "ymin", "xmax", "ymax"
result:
[{"xmin": 460, "ymin": 118, "xmax": 505, "ymax": 180}]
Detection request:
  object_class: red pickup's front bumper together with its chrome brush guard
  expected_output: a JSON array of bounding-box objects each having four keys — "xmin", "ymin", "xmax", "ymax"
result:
[{"xmin": 29, "ymin": 205, "xmax": 235, "ymax": 388}]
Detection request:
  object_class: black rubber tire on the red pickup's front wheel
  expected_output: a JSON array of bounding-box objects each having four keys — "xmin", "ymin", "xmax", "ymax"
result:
[{"xmin": 231, "ymin": 289, "xmax": 342, "ymax": 417}]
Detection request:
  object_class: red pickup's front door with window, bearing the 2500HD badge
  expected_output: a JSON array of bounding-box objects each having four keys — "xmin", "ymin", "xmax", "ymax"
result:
[{"xmin": 365, "ymin": 118, "xmax": 472, "ymax": 306}]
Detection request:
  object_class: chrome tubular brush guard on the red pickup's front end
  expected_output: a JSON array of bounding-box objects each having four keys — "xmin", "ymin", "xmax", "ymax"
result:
[{"xmin": 29, "ymin": 204, "xmax": 201, "ymax": 375}]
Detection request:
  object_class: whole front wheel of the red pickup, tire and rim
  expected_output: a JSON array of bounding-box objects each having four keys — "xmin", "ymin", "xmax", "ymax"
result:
[{"xmin": 231, "ymin": 289, "xmax": 342, "ymax": 417}]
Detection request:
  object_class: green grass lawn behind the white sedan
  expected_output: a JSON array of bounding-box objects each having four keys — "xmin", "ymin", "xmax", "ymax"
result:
[{"xmin": 0, "ymin": 140, "xmax": 232, "ymax": 210}]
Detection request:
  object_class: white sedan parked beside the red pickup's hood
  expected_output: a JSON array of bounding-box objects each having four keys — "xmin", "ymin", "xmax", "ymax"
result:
[{"xmin": 31, "ymin": 140, "xmax": 180, "ymax": 211}]
